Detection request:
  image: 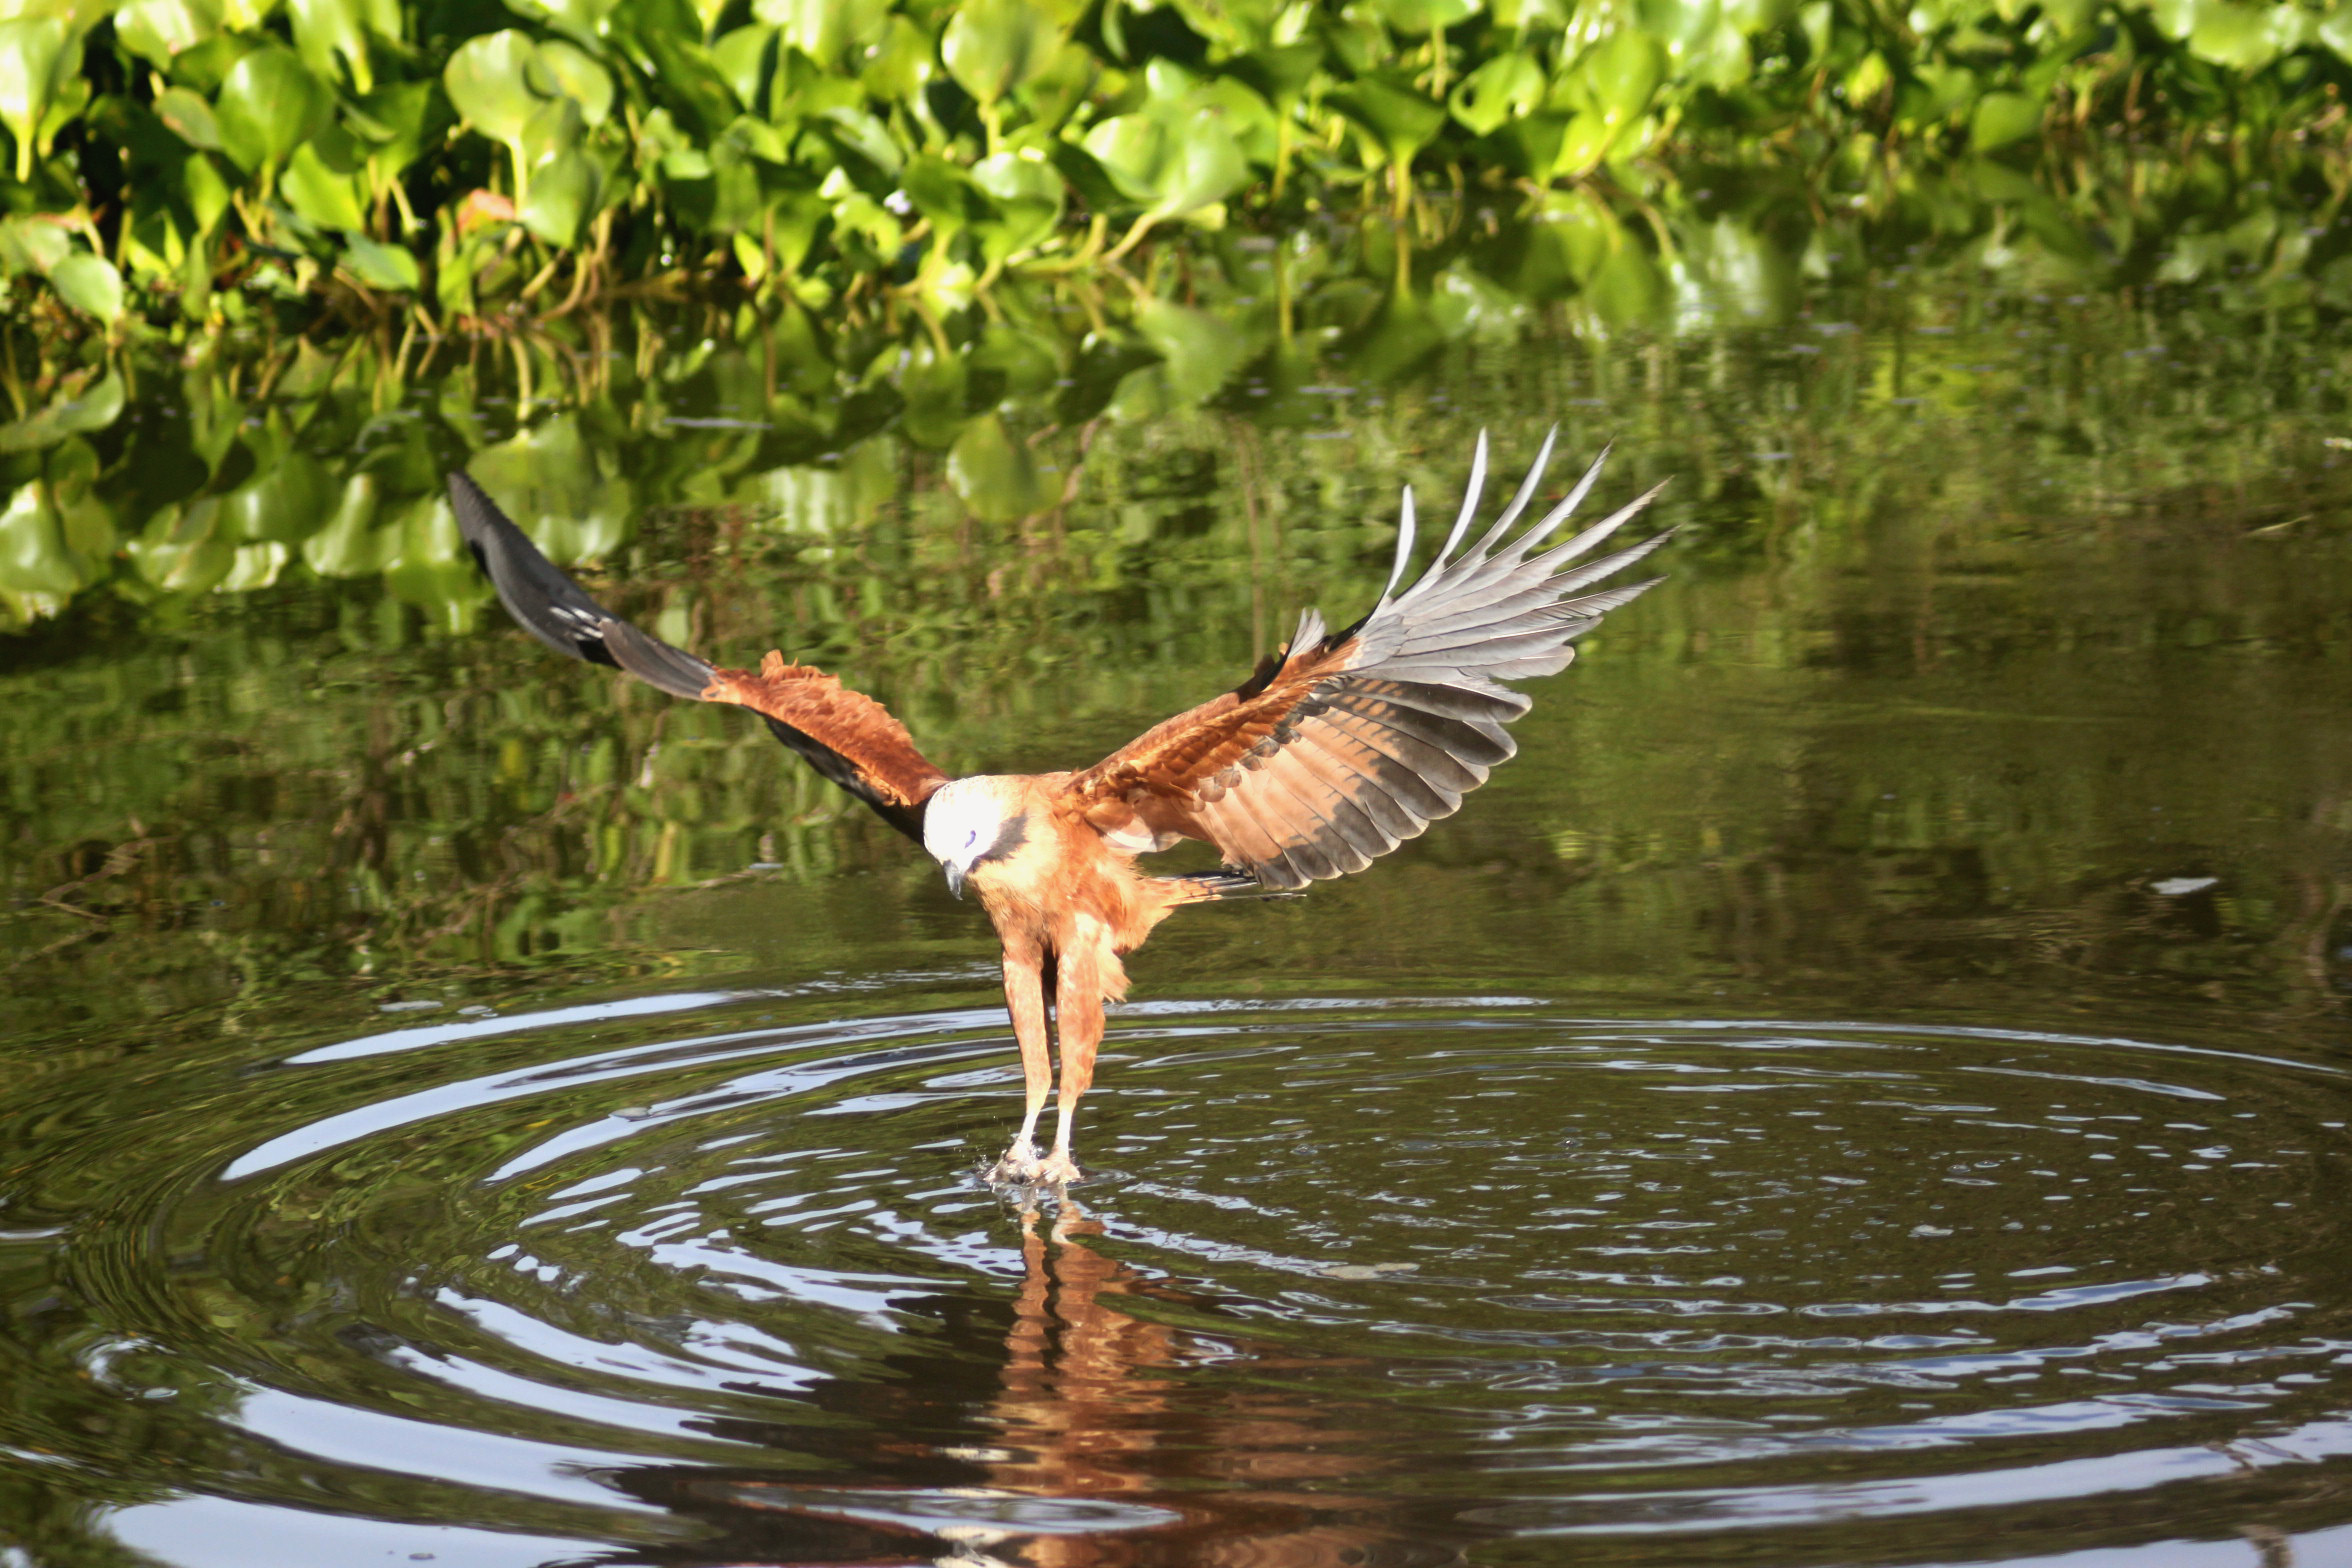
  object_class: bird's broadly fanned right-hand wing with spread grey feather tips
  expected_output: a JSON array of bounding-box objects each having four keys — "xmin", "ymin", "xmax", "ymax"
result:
[{"xmin": 1065, "ymin": 435, "xmax": 1672, "ymax": 889}]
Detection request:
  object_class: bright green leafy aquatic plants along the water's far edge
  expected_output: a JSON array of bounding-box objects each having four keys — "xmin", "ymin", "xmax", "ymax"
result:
[{"xmin": 0, "ymin": 0, "xmax": 2352, "ymax": 331}]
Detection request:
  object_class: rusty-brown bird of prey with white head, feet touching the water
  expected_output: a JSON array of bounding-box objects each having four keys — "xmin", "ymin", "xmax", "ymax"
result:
[{"xmin": 449, "ymin": 435, "xmax": 1672, "ymax": 1185}]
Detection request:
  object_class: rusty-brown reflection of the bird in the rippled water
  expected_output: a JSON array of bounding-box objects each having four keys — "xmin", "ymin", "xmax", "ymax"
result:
[{"xmin": 609, "ymin": 1201, "xmax": 1475, "ymax": 1568}]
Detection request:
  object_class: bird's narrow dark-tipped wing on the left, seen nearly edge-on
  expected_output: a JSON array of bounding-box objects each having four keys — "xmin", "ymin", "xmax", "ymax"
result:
[{"xmin": 449, "ymin": 473, "xmax": 948, "ymax": 842}]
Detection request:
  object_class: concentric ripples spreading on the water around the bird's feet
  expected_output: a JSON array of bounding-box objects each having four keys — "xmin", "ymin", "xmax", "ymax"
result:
[{"xmin": 13, "ymin": 976, "xmax": 2352, "ymax": 1563}]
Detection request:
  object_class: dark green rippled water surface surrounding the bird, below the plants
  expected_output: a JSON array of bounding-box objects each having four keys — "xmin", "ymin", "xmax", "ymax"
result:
[{"xmin": 0, "ymin": 199, "xmax": 2352, "ymax": 1568}]
